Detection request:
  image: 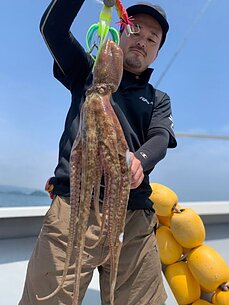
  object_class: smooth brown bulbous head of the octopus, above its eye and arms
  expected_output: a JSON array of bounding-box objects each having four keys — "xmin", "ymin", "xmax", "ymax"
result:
[{"xmin": 93, "ymin": 39, "xmax": 123, "ymax": 92}]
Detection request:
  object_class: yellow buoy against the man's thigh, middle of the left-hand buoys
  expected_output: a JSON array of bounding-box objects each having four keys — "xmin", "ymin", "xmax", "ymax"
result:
[{"xmin": 156, "ymin": 226, "xmax": 183, "ymax": 265}]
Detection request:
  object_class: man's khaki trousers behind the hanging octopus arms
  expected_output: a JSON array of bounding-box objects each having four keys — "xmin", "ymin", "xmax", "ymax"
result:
[{"xmin": 19, "ymin": 196, "xmax": 166, "ymax": 305}]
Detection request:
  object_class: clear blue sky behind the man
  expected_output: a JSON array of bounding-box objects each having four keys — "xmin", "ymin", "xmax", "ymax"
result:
[{"xmin": 0, "ymin": 0, "xmax": 229, "ymax": 201}]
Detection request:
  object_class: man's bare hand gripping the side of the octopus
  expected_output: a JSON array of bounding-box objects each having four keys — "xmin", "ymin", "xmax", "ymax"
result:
[{"xmin": 130, "ymin": 152, "xmax": 144, "ymax": 189}]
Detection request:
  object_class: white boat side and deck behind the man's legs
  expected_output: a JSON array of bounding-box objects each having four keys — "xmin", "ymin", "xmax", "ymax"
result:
[{"xmin": 0, "ymin": 201, "xmax": 229, "ymax": 305}]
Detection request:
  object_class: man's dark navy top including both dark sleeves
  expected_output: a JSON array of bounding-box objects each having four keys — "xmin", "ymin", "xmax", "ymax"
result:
[{"xmin": 40, "ymin": 0, "xmax": 176, "ymax": 209}]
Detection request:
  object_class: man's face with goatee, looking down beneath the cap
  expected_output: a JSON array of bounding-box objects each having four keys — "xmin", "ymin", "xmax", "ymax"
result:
[{"xmin": 120, "ymin": 14, "xmax": 162, "ymax": 74}]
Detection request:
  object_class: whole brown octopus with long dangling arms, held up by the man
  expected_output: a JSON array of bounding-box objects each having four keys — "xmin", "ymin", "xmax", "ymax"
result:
[{"xmin": 37, "ymin": 39, "xmax": 131, "ymax": 305}]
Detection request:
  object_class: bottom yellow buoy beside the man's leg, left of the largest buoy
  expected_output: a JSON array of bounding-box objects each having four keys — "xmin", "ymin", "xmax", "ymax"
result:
[{"xmin": 165, "ymin": 261, "xmax": 201, "ymax": 305}]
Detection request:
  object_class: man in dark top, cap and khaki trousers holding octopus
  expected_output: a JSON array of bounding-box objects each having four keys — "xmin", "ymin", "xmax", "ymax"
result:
[{"xmin": 19, "ymin": 0, "xmax": 176, "ymax": 305}]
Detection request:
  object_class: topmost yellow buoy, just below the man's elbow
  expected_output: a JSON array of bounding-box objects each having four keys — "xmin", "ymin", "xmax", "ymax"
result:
[{"xmin": 149, "ymin": 183, "xmax": 178, "ymax": 216}]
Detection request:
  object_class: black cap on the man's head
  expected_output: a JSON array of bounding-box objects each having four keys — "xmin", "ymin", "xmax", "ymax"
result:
[{"xmin": 126, "ymin": 2, "xmax": 169, "ymax": 48}]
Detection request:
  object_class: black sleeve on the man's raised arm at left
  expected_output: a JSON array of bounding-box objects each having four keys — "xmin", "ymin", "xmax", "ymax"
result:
[{"xmin": 40, "ymin": 0, "xmax": 91, "ymax": 90}]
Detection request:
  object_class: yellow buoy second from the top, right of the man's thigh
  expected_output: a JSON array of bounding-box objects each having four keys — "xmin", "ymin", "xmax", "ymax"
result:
[{"xmin": 170, "ymin": 208, "xmax": 205, "ymax": 249}]
